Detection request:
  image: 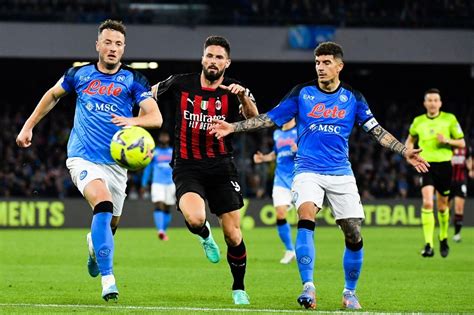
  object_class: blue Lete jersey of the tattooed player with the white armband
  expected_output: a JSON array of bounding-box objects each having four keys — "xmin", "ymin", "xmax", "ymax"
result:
[{"xmin": 267, "ymin": 80, "xmax": 378, "ymax": 175}]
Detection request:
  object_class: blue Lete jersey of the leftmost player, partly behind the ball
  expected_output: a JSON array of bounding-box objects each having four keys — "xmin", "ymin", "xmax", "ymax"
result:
[{"xmin": 61, "ymin": 64, "xmax": 152, "ymax": 164}]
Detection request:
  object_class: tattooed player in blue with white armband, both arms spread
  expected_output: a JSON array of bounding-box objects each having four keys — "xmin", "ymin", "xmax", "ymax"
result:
[{"xmin": 211, "ymin": 42, "xmax": 429, "ymax": 309}]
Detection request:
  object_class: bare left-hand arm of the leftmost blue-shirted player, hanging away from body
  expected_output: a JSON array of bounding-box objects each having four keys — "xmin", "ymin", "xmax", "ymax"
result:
[{"xmin": 16, "ymin": 82, "xmax": 67, "ymax": 148}]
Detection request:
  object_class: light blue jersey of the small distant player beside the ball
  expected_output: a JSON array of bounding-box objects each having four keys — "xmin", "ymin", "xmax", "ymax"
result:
[{"xmin": 142, "ymin": 147, "xmax": 173, "ymax": 187}]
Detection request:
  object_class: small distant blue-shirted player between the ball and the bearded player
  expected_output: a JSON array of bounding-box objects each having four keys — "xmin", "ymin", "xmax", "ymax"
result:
[{"xmin": 140, "ymin": 131, "xmax": 176, "ymax": 241}]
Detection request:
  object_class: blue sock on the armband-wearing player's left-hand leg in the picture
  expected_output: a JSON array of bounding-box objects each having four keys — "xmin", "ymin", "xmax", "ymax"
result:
[{"xmin": 296, "ymin": 225, "xmax": 316, "ymax": 284}]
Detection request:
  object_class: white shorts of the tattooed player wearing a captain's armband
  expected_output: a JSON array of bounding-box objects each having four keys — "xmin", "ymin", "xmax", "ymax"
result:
[{"xmin": 292, "ymin": 173, "xmax": 365, "ymax": 220}]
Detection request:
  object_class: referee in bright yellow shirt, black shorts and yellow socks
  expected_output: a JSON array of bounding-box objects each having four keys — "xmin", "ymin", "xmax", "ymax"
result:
[{"xmin": 405, "ymin": 89, "xmax": 466, "ymax": 257}]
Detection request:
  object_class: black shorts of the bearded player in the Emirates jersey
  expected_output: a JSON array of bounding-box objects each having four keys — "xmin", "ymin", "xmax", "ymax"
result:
[{"xmin": 173, "ymin": 157, "xmax": 244, "ymax": 216}]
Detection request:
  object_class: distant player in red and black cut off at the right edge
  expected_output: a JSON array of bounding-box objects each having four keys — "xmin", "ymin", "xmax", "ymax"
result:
[{"xmin": 451, "ymin": 146, "xmax": 474, "ymax": 242}]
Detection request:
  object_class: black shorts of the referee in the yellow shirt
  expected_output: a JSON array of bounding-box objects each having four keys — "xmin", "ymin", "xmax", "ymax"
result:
[{"xmin": 421, "ymin": 161, "xmax": 453, "ymax": 196}]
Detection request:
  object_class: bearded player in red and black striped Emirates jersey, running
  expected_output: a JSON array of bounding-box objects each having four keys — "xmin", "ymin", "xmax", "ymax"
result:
[{"xmin": 152, "ymin": 36, "xmax": 258, "ymax": 304}]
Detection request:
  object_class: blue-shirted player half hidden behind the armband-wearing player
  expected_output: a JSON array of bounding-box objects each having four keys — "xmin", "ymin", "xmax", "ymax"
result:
[{"xmin": 253, "ymin": 119, "xmax": 298, "ymax": 264}]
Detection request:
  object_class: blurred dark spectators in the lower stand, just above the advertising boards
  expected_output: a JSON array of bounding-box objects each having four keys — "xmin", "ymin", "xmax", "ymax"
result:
[{"xmin": 0, "ymin": 100, "xmax": 474, "ymax": 200}]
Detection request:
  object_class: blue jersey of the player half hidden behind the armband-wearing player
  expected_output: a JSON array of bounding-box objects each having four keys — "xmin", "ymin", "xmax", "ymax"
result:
[{"xmin": 273, "ymin": 127, "xmax": 298, "ymax": 189}]
